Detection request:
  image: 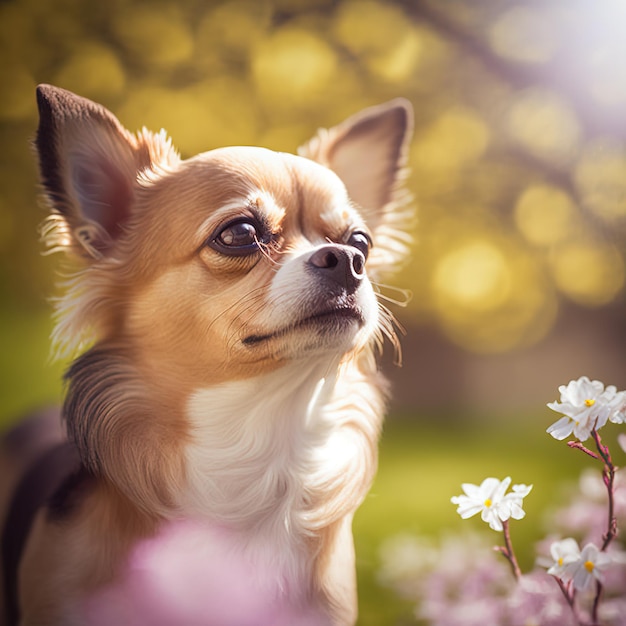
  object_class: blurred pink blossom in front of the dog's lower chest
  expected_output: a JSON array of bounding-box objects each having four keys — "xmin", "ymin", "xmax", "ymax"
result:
[{"xmin": 81, "ymin": 522, "xmax": 329, "ymax": 626}]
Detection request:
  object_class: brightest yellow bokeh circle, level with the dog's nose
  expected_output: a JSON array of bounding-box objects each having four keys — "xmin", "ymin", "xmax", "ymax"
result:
[{"xmin": 433, "ymin": 240, "xmax": 511, "ymax": 311}]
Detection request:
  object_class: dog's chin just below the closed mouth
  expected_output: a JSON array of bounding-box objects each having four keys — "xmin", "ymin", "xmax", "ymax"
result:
[{"xmin": 242, "ymin": 307, "xmax": 367, "ymax": 358}]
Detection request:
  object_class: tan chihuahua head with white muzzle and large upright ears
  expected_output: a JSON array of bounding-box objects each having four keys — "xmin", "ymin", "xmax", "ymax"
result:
[{"xmin": 36, "ymin": 85, "xmax": 412, "ymax": 386}]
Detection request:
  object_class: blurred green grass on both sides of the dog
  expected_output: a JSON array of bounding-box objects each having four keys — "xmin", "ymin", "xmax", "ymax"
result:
[{"xmin": 0, "ymin": 304, "xmax": 604, "ymax": 626}]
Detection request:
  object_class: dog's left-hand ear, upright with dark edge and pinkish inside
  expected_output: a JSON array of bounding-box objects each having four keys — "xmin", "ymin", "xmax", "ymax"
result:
[{"xmin": 35, "ymin": 85, "xmax": 178, "ymax": 259}]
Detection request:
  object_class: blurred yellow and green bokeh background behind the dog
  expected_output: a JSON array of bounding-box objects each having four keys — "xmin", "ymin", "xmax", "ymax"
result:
[{"xmin": 0, "ymin": 0, "xmax": 626, "ymax": 625}]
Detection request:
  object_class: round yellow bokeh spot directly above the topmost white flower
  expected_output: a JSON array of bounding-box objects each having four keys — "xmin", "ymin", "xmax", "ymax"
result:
[{"xmin": 551, "ymin": 242, "xmax": 624, "ymax": 306}]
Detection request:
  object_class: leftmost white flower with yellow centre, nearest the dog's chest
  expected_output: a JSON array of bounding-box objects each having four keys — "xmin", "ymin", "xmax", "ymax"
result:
[{"xmin": 451, "ymin": 476, "xmax": 532, "ymax": 531}]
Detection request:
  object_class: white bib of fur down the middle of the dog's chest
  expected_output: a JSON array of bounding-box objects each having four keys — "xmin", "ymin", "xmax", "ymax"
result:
[{"xmin": 179, "ymin": 360, "xmax": 350, "ymax": 597}]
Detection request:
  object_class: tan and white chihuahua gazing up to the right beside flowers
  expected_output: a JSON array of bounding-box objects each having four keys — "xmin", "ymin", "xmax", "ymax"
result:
[{"xmin": 3, "ymin": 85, "xmax": 412, "ymax": 626}]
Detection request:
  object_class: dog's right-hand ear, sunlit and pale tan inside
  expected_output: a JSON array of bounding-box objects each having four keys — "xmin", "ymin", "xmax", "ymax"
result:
[{"xmin": 298, "ymin": 98, "xmax": 413, "ymax": 273}]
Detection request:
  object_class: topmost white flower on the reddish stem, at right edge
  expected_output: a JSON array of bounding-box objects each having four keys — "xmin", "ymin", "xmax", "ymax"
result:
[{"xmin": 547, "ymin": 376, "xmax": 626, "ymax": 441}]
